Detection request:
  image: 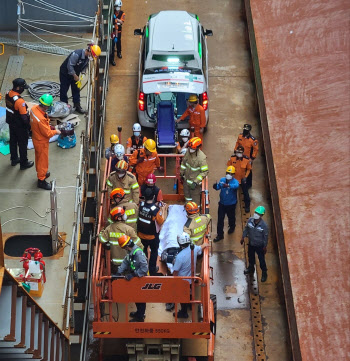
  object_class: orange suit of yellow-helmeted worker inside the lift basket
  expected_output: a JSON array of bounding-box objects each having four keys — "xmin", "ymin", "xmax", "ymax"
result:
[{"xmin": 129, "ymin": 149, "xmax": 160, "ymax": 186}]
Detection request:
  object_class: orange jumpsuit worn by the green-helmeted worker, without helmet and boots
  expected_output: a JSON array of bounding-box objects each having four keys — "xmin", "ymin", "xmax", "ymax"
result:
[{"xmin": 30, "ymin": 105, "xmax": 57, "ymax": 180}]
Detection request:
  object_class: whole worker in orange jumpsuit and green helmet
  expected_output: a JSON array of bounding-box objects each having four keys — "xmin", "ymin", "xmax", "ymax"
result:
[{"xmin": 30, "ymin": 94, "xmax": 61, "ymax": 190}]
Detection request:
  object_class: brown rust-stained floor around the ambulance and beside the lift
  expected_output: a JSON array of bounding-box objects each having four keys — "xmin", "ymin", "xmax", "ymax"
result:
[{"xmin": 105, "ymin": 0, "xmax": 291, "ymax": 361}]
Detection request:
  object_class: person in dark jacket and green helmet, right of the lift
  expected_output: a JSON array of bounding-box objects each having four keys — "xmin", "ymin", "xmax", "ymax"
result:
[{"xmin": 241, "ymin": 206, "xmax": 269, "ymax": 282}]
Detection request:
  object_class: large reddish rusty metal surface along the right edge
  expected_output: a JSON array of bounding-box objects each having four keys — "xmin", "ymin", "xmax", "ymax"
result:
[{"xmin": 246, "ymin": 0, "xmax": 350, "ymax": 360}]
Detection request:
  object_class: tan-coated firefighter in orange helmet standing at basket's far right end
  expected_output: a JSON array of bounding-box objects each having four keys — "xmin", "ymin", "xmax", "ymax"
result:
[{"xmin": 180, "ymin": 137, "xmax": 209, "ymax": 204}]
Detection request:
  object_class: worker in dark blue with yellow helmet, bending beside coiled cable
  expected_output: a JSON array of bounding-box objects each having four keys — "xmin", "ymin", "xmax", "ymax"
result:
[{"xmin": 59, "ymin": 45, "xmax": 101, "ymax": 114}]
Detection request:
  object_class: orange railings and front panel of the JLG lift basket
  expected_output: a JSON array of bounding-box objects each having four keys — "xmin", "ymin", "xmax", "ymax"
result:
[{"xmin": 92, "ymin": 154, "xmax": 214, "ymax": 338}]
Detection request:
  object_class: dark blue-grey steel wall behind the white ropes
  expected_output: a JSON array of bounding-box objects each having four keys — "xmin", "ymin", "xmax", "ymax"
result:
[{"xmin": 0, "ymin": 0, "xmax": 98, "ymax": 32}]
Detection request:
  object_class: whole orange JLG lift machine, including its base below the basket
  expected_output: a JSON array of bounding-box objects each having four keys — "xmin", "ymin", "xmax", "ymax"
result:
[{"xmin": 92, "ymin": 154, "xmax": 216, "ymax": 361}]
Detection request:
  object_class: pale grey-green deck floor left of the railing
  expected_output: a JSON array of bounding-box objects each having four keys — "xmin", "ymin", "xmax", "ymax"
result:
[{"xmin": 0, "ymin": 38, "xmax": 85, "ymax": 327}]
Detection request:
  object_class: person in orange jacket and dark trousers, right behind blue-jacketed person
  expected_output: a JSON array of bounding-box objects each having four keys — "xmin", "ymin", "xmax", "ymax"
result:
[{"xmin": 227, "ymin": 145, "xmax": 252, "ymax": 213}]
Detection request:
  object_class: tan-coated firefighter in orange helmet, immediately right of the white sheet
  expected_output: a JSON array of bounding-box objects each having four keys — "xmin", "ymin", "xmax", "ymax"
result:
[{"xmin": 183, "ymin": 202, "xmax": 211, "ymax": 245}]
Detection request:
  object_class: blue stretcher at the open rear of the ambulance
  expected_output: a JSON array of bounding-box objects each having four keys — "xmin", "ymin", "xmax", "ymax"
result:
[{"xmin": 155, "ymin": 100, "xmax": 177, "ymax": 148}]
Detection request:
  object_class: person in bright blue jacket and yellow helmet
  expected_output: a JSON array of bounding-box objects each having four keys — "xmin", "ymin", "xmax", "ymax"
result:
[{"xmin": 213, "ymin": 165, "xmax": 239, "ymax": 242}]
